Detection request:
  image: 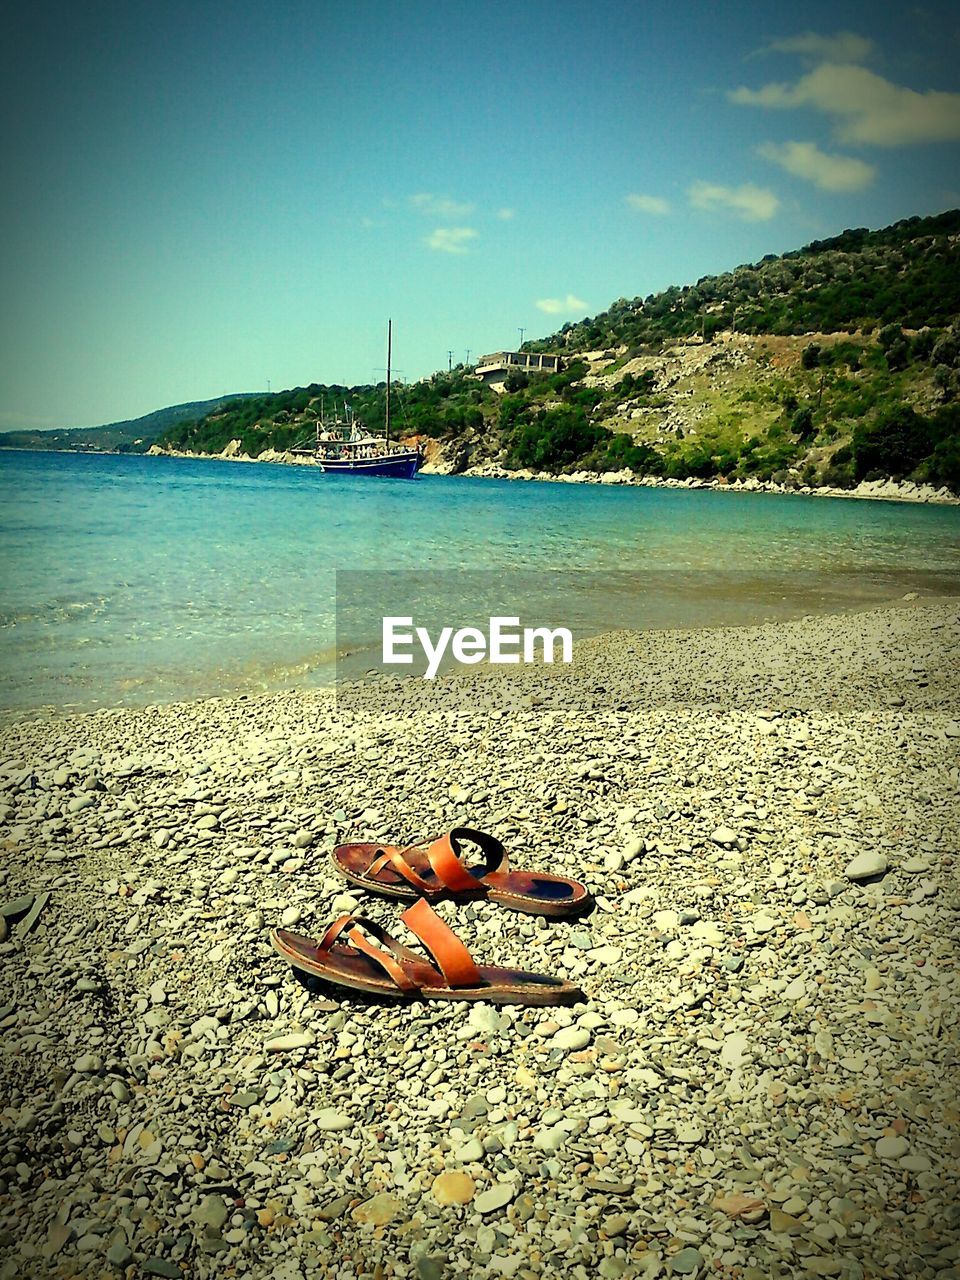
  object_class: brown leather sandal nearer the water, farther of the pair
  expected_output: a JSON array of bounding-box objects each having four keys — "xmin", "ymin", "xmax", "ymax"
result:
[{"xmin": 333, "ymin": 827, "xmax": 593, "ymax": 916}]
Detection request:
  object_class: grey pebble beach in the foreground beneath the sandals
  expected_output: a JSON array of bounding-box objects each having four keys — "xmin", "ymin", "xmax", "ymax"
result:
[{"xmin": 0, "ymin": 602, "xmax": 960, "ymax": 1280}]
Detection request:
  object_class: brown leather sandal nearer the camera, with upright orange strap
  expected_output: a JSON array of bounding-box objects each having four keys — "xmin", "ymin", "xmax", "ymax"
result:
[{"xmin": 271, "ymin": 899, "xmax": 585, "ymax": 1005}]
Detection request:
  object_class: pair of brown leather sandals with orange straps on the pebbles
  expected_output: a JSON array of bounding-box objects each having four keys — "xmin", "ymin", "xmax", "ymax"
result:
[{"xmin": 271, "ymin": 827, "xmax": 593, "ymax": 1005}]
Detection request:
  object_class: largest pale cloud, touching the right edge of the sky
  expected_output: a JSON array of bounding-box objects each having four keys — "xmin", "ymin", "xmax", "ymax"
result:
[{"xmin": 728, "ymin": 63, "xmax": 960, "ymax": 147}]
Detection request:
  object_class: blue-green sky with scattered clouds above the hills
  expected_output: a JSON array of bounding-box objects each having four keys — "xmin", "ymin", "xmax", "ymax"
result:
[{"xmin": 0, "ymin": 0, "xmax": 960, "ymax": 429}]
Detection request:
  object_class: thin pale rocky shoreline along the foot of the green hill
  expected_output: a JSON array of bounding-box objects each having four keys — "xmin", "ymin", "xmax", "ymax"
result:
[{"xmin": 142, "ymin": 442, "xmax": 960, "ymax": 507}]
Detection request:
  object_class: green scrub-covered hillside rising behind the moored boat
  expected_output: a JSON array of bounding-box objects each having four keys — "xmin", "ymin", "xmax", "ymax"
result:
[{"xmin": 160, "ymin": 210, "xmax": 960, "ymax": 489}]
